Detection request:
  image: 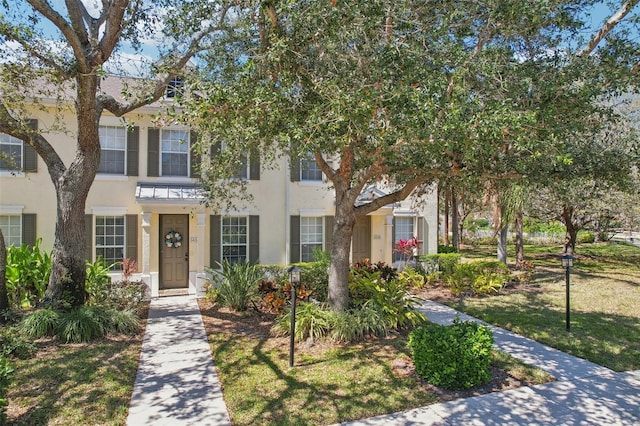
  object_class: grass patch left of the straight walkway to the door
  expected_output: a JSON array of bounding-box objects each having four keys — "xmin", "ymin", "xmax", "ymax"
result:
[{"xmin": 7, "ymin": 318, "xmax": 142, "ymax": 425}]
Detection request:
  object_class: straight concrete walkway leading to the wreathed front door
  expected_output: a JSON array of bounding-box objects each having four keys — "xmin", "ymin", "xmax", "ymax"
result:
[{"xmin": 127, "ymin": 296, "xmax": 231, "ymax": 426}]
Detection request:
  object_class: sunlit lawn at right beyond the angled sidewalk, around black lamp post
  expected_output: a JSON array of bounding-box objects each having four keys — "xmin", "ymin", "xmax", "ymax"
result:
[{"xmin": 449, "ymin": 244, "xmax": 640, "ymax": 371}]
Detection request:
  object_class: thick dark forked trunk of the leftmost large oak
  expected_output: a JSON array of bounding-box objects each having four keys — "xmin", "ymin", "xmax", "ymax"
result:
[{"xmin": 43, "ymin": 75, "xmax": 101, "ymax": 309}]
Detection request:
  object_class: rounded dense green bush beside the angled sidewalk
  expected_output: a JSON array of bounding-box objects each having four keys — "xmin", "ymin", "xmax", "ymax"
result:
[{"xmin": 409, "ymin": 318, "xmax": 493, "ymax": 389}]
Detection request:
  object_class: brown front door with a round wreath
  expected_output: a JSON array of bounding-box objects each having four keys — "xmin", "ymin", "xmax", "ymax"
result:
[{"xmin": 160, "ymin": 214, "xmax": 189, "ymax": 290}]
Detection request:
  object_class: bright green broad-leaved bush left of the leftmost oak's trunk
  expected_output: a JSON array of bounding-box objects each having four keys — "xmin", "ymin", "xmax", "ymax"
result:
[{"xmin": 6, "ymin": 238, "xmax": 51, "ymax": 308}]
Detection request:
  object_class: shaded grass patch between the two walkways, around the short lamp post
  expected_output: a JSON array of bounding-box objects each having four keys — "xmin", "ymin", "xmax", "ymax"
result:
[{"xmin": 201, "ymin": 305, "xmax": 551, "ymax": 425}]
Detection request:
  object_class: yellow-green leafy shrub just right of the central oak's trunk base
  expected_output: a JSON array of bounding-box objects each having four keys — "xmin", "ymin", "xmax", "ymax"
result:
[{"xmin": 349, "ymin": 271, "xmax": 426, "ymax": 329}]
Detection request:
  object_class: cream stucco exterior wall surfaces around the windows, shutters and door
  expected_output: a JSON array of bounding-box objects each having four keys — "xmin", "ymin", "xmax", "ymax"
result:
[{"xmin": 0, "ymin": 82, "xmax": 437, "ymax": 296}]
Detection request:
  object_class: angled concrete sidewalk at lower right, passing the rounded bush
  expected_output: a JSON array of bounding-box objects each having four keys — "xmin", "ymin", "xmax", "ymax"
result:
[{"xmin": 342, "ymin": 301, "xmax": 640, "ymax": 426}]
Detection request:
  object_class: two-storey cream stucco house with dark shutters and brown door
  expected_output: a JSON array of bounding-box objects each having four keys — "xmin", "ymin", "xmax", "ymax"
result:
[{"xmin": 0, "ymin": 77, "xmax": 437, "ymax": 296}]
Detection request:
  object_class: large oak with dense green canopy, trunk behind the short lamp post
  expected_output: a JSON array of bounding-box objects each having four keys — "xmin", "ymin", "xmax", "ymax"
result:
[{"xmin": 182, "ymin": 0, "xmax": 638, "ymax": 310}]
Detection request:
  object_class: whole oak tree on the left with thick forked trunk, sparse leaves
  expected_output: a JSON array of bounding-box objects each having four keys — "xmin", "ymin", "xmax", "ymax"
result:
[{"xmin": 0, "ymin": 0, "xmax": 234, "ymax": 307}]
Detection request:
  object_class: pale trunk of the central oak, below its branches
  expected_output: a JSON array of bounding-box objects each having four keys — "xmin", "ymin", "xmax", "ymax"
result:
[{"xmin": 328, "ymin": 190, "xmax": 356, "ymax": 312}]
